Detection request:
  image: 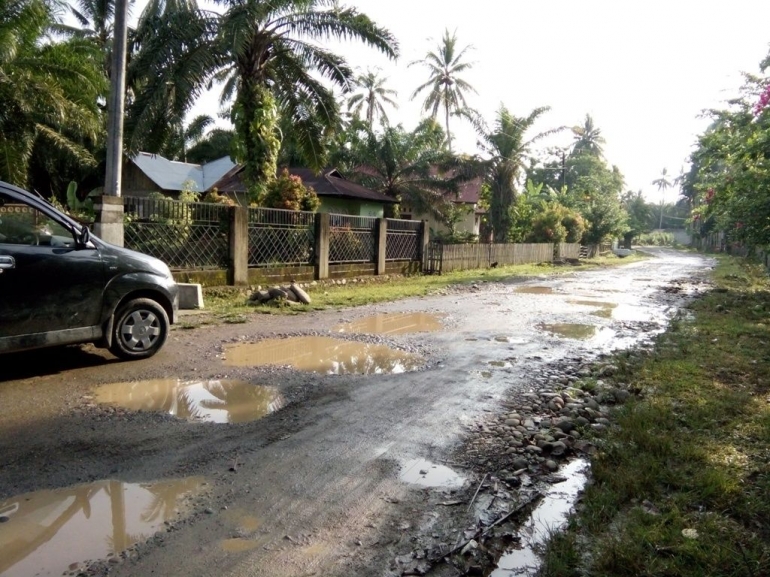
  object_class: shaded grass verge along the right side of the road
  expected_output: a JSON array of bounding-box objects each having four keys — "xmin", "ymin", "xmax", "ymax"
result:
[{"xmin": 540, "ymin": 257, "xmax": 770, "ymax": 577}]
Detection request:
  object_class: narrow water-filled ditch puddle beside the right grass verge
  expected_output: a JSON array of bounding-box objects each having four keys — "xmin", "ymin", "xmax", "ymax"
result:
[{"xmin": 490, "ymin": 459, "xmax": 588, "ymax": 577}]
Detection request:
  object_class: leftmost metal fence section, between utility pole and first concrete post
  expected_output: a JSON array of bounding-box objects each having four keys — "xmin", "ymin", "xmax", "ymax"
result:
[{"xmin": 123, "ymin": 197, "xmax": 230, "ymax": 270}]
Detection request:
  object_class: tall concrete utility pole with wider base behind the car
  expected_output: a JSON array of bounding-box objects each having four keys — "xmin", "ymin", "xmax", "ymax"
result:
[{"xmin": 94, "ymin": 0, "xmax": 128, "ymax": 246}]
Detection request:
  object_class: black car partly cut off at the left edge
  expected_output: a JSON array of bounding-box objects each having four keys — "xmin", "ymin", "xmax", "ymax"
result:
[{"xmin": 0, "ymin": 181, "xmax": 178, "ymax": 359}]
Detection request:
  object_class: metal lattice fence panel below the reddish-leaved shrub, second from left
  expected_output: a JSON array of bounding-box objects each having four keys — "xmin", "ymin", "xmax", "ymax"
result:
[{"xmin": 249, "ymin": 208, "xmax": 315, "ymax": 267}]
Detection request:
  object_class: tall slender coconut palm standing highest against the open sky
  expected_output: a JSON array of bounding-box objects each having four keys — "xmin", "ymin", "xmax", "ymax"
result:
[{"xmin": 409, "ymin": 30, "xmax": 476, "ymax": 152}]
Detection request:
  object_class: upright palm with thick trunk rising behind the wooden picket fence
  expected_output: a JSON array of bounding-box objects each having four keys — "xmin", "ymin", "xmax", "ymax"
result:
[{"xmin": 476, "ymin": 106, "xmax": 561, "ymax": 242}]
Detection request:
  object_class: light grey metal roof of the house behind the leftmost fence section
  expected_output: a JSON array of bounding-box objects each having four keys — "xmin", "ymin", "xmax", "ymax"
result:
[{"xmin": 131, "ymin": 152, "xmax": 235, "ymax": 192}]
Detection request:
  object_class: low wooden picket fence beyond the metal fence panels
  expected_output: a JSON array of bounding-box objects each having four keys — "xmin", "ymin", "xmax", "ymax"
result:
[{"xmin": 426, "ymin": 243, "xmax": 580, "ymax": 274}]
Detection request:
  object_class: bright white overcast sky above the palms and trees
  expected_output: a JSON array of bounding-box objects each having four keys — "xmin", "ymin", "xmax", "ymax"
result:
[{"xmin": 172, "ymin": 0, "xmax": 770, "ymax": 202}]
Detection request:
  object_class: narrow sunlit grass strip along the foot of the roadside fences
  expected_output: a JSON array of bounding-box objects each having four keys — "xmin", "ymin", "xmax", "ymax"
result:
[{"xmin": 195, "ymin": 254, "xmax": 648, "ymax": 324}]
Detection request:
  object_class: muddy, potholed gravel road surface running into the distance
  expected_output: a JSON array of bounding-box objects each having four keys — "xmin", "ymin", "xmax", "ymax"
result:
[{"xmin": 0, "ymin": 250, "xmax": 711, "ymax": 577}]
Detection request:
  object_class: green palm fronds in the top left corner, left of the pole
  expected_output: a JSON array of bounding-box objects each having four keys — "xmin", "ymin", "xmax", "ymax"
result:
[{"xmin": 0, "ymin": 0, "xmax": 107, "ymax": 186}]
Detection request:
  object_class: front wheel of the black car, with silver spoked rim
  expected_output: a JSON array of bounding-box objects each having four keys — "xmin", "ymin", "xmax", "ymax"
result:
[{"xmin": 110, "ymin": 298, "xmax": 169, "ymax": 360}]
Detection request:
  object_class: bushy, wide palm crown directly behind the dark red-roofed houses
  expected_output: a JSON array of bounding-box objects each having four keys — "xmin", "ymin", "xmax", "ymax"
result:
[{"xmin": 343, "ymin": 119, "xmax": 472, "ymax": 221}]
